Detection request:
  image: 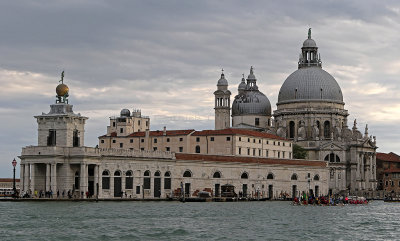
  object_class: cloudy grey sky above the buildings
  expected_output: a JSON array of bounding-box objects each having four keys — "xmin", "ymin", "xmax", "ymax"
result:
[{"xmin": 0, "ymin": 0, "xmax": 400, "ymax": 177}]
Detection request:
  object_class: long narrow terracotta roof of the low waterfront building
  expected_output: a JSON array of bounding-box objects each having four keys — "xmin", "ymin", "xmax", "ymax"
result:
[{"xmin": 175, "ymin": 153, "xmax": 327, "ymax": 167}]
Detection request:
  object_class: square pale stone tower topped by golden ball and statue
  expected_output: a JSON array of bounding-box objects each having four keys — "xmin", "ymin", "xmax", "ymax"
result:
[{"xmin": 35, "ymin": 71, "xmax": 88, "ymax": 147}]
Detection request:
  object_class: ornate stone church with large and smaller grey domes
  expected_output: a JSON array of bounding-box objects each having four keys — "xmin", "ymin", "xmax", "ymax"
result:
[{"xmin": 216, "ymin": 29, "xmax": 377, "ymax": 194}]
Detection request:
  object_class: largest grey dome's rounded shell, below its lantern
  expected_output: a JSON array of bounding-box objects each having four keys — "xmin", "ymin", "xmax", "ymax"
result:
[{"xmin": 278, "ymin": 67, "xmax": 343, "ymax": 104}]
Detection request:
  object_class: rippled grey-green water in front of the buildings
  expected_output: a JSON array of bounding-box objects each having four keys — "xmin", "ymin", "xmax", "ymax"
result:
[{"xmin": 0, "ymin": 201, "xmax": 400, "ymax": 240}]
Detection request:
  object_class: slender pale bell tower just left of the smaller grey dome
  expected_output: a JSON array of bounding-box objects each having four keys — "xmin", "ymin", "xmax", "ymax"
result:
[{"xmin": 214, "ymin": 69, "xmax": 231, "ymax": 130}]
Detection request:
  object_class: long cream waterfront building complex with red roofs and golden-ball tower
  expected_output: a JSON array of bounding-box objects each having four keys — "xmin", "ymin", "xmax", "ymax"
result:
[{"xmin": 20, "ymin": 74, "xmax": 329, "ymax": 199}]
